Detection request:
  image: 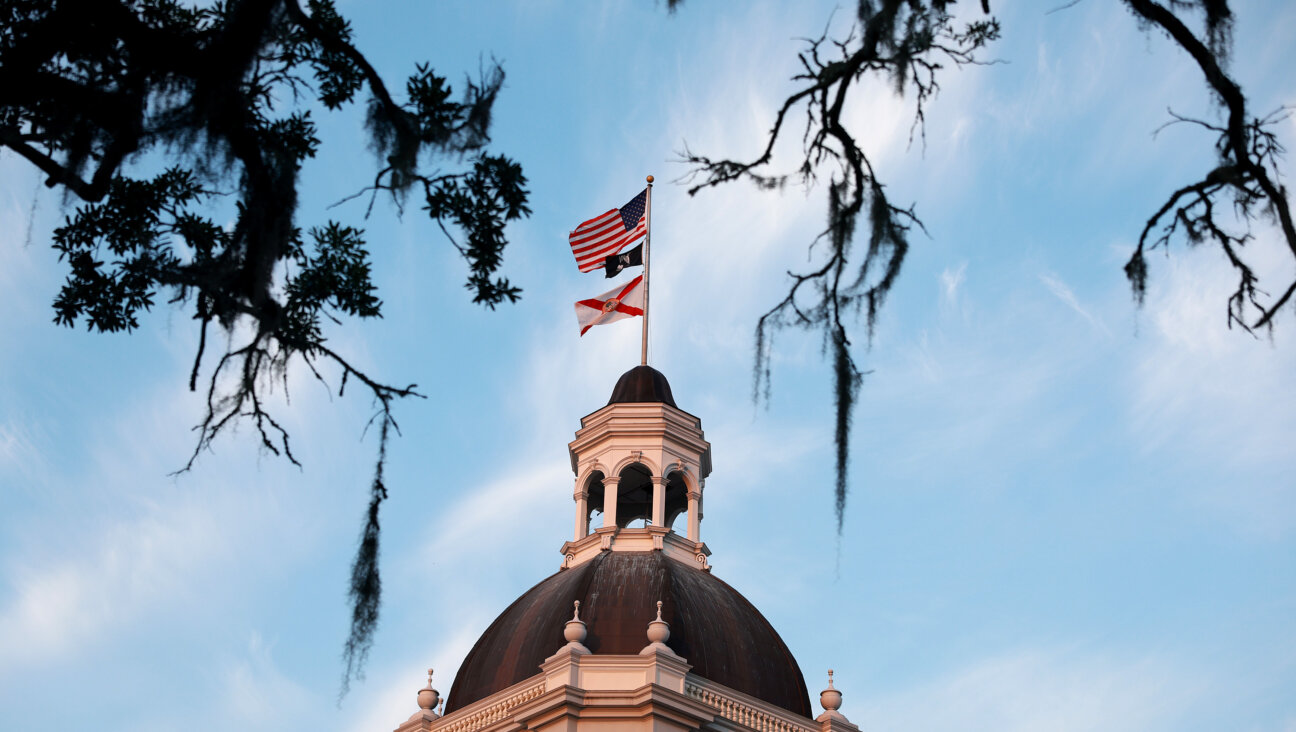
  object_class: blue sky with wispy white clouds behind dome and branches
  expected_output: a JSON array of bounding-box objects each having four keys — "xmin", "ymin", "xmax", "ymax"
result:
[{"xmin": 0, "ymin": 0, "xmax": 1296, "ymax": 732}]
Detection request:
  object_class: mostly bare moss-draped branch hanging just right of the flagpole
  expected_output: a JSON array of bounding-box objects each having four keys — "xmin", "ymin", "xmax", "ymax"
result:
[{"xmin": 680, "ymin": 0, "xmax": 999, "ymax": 531}]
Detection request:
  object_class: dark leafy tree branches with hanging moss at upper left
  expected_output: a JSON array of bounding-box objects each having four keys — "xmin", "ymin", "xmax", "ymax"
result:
[{"xmin": 0, "ymin": 0, "xmax": 530, "ymax": 676}]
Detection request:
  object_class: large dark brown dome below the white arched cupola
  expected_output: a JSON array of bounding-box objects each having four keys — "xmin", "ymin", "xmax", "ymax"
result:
[{"xmin": 446, "ymin": 554, "xmax": 811, "ymax": 716}]
